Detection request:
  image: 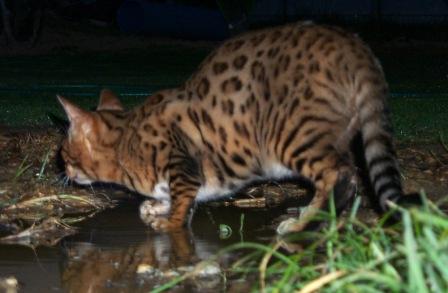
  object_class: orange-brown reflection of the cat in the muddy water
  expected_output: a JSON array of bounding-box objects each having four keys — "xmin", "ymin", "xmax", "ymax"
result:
[{"xmin": 62, "ymin": 230, "xmax": 223, "ymax": 292}]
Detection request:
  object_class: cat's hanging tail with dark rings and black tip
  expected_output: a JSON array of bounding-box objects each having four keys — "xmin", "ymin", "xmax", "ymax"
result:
[{"xmin": 356, "ymin": 68, "xmax": 403, "ymax": 211}]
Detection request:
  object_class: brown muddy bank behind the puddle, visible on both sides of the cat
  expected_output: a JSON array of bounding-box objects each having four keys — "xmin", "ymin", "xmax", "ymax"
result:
[{"xmin": 0, "ymin": 127, "xmax": 448, "ymax": 246}]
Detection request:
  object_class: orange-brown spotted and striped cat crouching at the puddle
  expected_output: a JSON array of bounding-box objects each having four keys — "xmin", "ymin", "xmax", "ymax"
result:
[{"xmin": 59, "ymin": 22, "xmax": 418, "ymax": 234}]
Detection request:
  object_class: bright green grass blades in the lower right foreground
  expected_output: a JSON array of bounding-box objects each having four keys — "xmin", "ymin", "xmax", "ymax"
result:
[{"xmin": 155, "ymin": 194, "xmax": 448, "ymax": 293}]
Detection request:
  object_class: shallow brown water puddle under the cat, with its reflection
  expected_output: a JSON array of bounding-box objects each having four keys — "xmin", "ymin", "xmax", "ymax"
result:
[{"xmin": 0, "ymin": 200, "xmax": 275, "ymax": 292}]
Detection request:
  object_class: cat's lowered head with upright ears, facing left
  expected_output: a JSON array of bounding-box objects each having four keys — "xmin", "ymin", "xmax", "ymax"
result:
[{"xmin": 58, "ymin": 90, "xmax": 125, "ymax": 184}]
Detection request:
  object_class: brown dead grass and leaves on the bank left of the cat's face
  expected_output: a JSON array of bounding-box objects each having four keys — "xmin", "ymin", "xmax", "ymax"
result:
[{"xmin": 0, "ymin": 130, "xmax": 114, "ymax": 246}]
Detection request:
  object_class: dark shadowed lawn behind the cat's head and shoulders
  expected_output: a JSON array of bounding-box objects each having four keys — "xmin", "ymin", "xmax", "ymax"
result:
[{"xmin": 0, "ymin": 45, "xmax": 209, "ymax": 126}]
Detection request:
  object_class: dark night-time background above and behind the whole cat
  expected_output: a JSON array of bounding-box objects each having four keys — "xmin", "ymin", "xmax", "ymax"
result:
[{"xmin": 0, "ymin": 0, "xmax": 448, "ymax": 140}]
